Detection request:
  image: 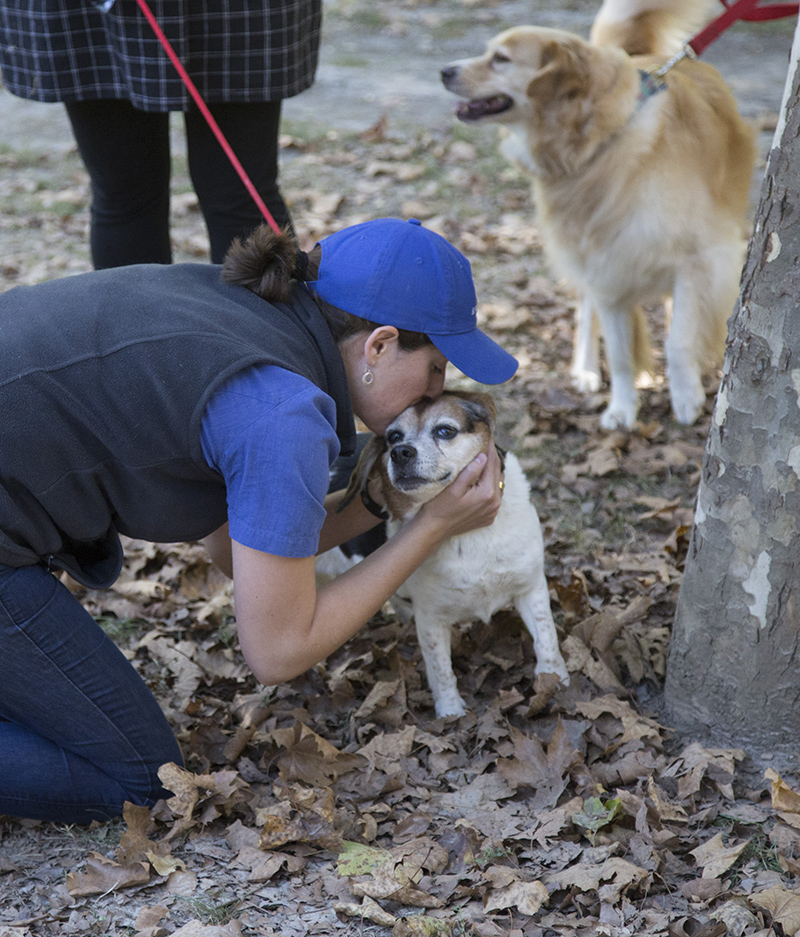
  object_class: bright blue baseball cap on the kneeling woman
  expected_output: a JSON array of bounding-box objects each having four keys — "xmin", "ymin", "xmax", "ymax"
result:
[{"xmin": 309, "ymin": 218, "xmax": 519, "ymax": 384}]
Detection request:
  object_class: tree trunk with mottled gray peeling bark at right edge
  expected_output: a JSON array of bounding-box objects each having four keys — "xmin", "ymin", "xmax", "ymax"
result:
[{"xmin": 665, "ymin": 26, "xmax": 800, "ymax": 758}]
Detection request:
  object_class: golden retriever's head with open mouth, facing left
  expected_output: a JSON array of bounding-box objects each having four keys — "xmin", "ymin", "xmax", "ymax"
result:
[{"xmin": 441, "ymin": 26, "xmax": 636, "ymax": 172}]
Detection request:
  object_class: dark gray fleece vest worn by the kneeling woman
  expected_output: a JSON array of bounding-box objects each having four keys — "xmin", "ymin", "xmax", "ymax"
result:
[{"xmin": 0, "ymin": 264, "xmax": 355, "ymax": 588}]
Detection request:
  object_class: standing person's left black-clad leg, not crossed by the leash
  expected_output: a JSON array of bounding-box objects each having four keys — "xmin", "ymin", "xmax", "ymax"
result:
[{"xmin": 66, "ymin": 100, "xmax": 172, "ymax": 270}]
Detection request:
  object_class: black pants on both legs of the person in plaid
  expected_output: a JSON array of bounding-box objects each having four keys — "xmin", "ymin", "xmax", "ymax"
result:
[{"xmin": 66, "ymin": 100, "xmax": 291, "ymax": 269}]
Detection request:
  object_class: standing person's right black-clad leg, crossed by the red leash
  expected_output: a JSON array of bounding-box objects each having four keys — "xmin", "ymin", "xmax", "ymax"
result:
[{"xmin": 186, "ymin": 101, "xmax": 291, "ymax": 263}]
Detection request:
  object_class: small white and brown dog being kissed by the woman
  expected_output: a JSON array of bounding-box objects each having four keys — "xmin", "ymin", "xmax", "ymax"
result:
[{"xmin": 344, "ymin": 392, "xmax": 569, "ymax": 716}]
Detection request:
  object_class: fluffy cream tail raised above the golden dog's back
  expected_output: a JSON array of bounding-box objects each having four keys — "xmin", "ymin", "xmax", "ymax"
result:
[{"xmin": 590, "ymin": 0, "xmax": 713, "ymax": 55}]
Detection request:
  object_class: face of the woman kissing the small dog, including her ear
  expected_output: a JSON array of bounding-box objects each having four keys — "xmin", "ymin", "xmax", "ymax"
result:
[{"xmin": 343, "ymin": 326, "xmax": 447, "ymax": 436}]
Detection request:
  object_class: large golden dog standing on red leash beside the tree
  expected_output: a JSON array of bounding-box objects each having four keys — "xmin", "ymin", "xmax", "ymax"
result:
[{"xmin": 442, "ymin": 0, "xmax": 755, "ymax": 429}]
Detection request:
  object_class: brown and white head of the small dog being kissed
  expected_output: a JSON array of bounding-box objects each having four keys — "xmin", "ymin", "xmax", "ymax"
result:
[{"xmin": 344, "ymin": 391, "xmax": 497, "ymax": 519}]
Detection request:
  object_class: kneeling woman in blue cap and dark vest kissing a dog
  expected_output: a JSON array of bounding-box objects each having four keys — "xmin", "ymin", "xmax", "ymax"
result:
[{"xmin": 0, "ymin": 219, "xmax": 516, "ymax": 823}]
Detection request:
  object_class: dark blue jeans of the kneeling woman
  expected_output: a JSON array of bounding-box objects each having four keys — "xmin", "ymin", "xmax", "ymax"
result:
[{"xmin": 0, "ymin": 565, "xmax": 183, "ymax": 823}]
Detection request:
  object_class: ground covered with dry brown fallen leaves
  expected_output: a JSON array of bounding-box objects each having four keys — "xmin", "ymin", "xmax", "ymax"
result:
[{"xmin": 0, "ymin": 0, "xmax": 800, "ymax": 937}]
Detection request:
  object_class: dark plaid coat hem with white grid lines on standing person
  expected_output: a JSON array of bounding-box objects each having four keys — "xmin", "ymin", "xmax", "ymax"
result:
[{"xmin": 0, "ymin": 0, "xmax": 322, "ymax": 111}]
